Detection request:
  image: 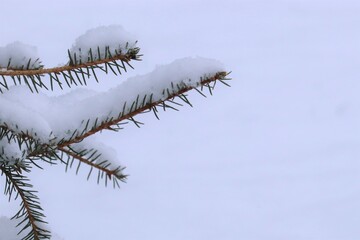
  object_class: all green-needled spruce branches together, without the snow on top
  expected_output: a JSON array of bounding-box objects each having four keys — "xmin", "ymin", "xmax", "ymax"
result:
[{"xmin": 0, "ymin": 29, "xmax": 230, "ymax": 240}]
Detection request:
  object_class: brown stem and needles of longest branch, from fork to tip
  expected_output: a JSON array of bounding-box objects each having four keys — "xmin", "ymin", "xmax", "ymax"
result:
[{"xmin": 58, "ymin": 72, "xmax": 230, "ymax": 149}]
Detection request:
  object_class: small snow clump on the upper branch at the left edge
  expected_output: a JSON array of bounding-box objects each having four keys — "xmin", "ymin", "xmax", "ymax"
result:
[{"xmin": 0, "ymin": 41, "xmax": 41, "ymax": 71}]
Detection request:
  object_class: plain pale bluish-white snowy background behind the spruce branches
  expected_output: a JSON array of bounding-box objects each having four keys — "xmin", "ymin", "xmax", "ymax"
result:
[{"xmin": 0, "ymin": 0, "xmax": 360, "ymax": 240}]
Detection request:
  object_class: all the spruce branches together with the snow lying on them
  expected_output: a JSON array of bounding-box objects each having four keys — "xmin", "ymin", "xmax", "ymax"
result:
[{"xmin": 0, "ymin": 23, "xmax": 230, "ymax": 239}]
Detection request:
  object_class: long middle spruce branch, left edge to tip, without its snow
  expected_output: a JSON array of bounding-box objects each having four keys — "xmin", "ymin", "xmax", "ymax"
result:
[{"xmin": 1, "ymin": 72, "xmax": 230, "ymax": 163}]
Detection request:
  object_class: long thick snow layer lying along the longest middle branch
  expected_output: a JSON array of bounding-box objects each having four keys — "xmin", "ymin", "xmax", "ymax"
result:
[{"xmin": 0, "ymin": 57, "xmax": 224, "ymax": 165}]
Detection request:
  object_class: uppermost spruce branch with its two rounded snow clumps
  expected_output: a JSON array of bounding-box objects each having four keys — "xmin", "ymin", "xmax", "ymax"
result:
[{"xmin": 0, "ymin": 25, "xmax": 142, "ymax": 92}]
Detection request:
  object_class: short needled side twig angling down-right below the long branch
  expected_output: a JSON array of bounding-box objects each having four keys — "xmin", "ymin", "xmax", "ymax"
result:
[{"xmin": 58, "ymin": 147, "xmax": 127, "ymax": 187}]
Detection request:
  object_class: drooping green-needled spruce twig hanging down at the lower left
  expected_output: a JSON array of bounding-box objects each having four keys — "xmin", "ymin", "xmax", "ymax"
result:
[{"xmin": 0, "ymin": 166, "xmax": 51, "ymax": 240}]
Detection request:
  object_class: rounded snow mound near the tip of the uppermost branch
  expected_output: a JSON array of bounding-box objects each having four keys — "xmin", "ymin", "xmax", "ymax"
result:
[{"xmin": 70, "ymin": 25, "xmax": 136, "ymax": 63}]
